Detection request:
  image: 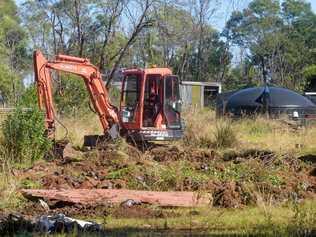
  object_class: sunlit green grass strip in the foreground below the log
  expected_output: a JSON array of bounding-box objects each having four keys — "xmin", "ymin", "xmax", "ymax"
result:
[{"xmin": 99, "ymin": 200, "xmax": 316, "ymax": 236}]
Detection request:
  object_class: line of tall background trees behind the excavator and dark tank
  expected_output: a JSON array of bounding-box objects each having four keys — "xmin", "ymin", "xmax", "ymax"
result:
[{"xmin": 0, "ymin": 0, "xmax": 316, "ymax": 107}]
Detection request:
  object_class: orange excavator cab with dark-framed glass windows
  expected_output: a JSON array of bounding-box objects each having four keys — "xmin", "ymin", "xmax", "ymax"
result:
[{"xmin": 119, "ymin": 68, "xmax": 183, "ymax": 141}]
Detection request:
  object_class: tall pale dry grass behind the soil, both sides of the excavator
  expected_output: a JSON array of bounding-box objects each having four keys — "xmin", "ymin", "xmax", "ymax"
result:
[{"xmin": 56, "ymin": 108, "xmax": 316, "ymax": 154}]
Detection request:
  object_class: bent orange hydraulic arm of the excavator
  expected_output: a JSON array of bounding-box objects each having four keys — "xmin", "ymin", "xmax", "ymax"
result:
[{"xmin": 33, "ymin": 51, "xmax": 119, "ymax": 137}]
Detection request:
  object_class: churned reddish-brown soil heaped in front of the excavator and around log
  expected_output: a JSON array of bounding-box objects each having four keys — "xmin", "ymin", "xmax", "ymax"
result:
[{"xmin": 11, "ymin": 142, "xmax": 316, "ymax": 218}]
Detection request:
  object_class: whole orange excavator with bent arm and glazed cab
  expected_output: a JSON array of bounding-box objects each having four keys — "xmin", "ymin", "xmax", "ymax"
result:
[{"xmin": 33, "ymin": 51, "xmax": 183, "ymax": 146}]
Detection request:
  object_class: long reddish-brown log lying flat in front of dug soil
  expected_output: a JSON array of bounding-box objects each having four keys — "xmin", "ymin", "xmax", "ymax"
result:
[{"xmin": 21, "ymin": 189, "xmax": 212, "ymax": 207}]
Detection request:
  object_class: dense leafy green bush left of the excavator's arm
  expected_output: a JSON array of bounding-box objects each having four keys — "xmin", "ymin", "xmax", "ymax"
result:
[{"xmin": 3, "ymin": 108, "xmax": 51, "ymax": 164}]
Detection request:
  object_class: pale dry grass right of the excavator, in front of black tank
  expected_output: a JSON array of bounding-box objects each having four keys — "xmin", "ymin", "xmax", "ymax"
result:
[{"xmin": 183, "ymin": 109, "xmax": 316, "ymax": 154}]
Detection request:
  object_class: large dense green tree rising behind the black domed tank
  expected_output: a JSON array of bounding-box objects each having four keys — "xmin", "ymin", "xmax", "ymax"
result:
[{"xmin": 223, "ymin": 0, "xmax": 316, "ymax": 90}]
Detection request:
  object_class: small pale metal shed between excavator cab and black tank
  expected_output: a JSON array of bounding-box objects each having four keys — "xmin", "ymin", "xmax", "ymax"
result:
[{"xmin": 180, "ymin": 81, "xmax": 222, "ymax": 107}]
